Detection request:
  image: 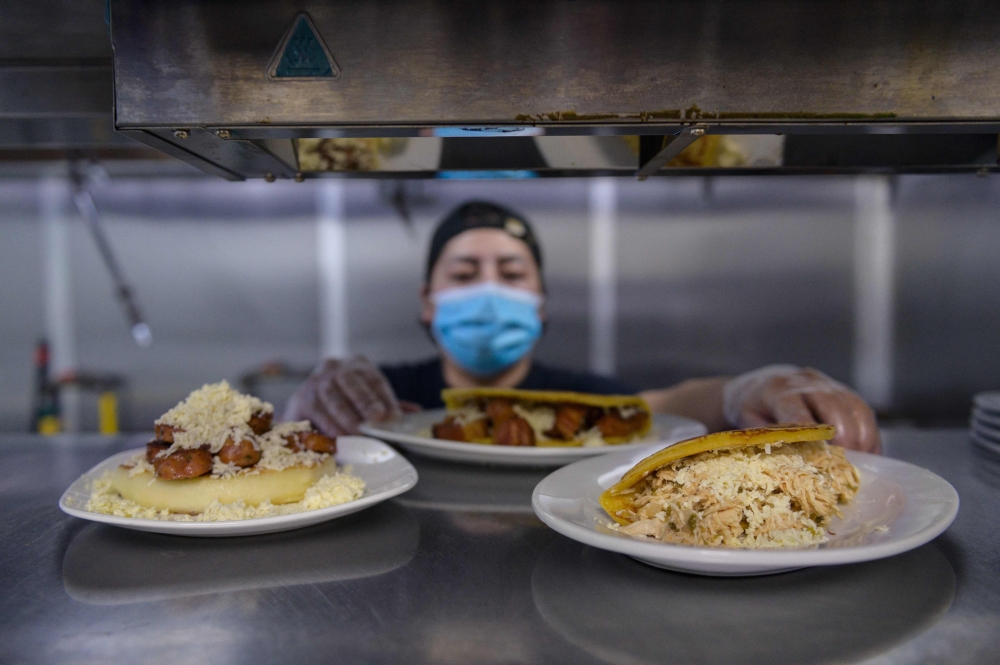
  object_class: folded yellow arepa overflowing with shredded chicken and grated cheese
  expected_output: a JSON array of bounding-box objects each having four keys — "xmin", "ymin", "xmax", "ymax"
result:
[{"xmin": 600, "ymin": 425, "xmax": 861, "ymax": 549}]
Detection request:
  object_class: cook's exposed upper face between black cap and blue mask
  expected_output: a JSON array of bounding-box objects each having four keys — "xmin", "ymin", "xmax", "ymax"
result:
[{"xmin": 421, "ymin": 229, "xmax": 542, "ymax": 323}]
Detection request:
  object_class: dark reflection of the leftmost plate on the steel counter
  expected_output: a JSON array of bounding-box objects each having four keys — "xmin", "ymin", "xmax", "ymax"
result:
[{"xmin": 62, "ymin": 501, "xmax": 420, "ymax": 605}]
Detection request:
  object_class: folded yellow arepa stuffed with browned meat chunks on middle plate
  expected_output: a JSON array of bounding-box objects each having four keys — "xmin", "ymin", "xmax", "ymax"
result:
[{"xmin": 430, "ymin": 388, "xmax": 652, "ymax": 447}]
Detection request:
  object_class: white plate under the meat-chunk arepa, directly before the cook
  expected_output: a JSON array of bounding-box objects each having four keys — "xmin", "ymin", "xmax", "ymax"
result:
[{"xmin": 361, "ymin": 409, "xmax": 708, "ymax": 466}]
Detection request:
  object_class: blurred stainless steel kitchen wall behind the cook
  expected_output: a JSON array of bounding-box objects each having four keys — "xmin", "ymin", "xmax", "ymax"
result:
[{"xmin": 0, "ymin": 169, "xmax": 1000, "ymax": 431}]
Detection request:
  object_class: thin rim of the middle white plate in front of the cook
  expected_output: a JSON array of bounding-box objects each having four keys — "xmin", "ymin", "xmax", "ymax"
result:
[{"xmin": 358, "ymin": 409, "xmax": 708, "ymax": 462}]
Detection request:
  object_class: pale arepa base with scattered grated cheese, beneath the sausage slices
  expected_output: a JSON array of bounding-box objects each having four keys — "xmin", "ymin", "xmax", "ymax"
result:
[{"xmin": 87, "ymin": 469, "xmax": 365, "ymax": 522}]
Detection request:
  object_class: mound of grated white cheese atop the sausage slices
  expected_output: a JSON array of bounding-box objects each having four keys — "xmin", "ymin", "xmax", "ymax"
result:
[{"xmin": 156, "ymin": 381, "xmax": 274, "ymax": 453}]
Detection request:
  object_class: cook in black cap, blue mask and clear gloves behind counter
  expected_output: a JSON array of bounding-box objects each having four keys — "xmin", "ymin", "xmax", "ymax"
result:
[{"xmin": 285, "ymin": 201, "xmax": 880, "ymax": 452}]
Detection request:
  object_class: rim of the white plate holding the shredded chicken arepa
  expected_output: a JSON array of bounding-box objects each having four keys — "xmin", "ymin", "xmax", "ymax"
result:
[{"xmin": 531, "ymin": 450, "xmax": 961, "ymax": 574}]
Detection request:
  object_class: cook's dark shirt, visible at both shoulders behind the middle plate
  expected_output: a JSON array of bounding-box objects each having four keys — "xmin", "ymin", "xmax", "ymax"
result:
[{"xmin": 379, "ymin": 358, "xmax": 635, "ymax": 409}]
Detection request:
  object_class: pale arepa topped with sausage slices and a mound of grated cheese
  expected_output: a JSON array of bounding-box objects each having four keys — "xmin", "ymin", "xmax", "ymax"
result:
[{"xmin": 87, "ymin": 381, "xmax": 364, "ymax": 521}]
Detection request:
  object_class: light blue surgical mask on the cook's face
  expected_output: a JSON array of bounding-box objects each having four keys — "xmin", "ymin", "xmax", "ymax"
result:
[{"xmin": 431, "ymin": 282, "xmax": 542, "ymax": 376}]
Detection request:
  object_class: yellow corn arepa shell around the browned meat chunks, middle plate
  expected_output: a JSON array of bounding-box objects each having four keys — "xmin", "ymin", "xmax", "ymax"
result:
[{"xmin": 441, "ymin": 388, "xmax": 653, "ymax": 447}]
